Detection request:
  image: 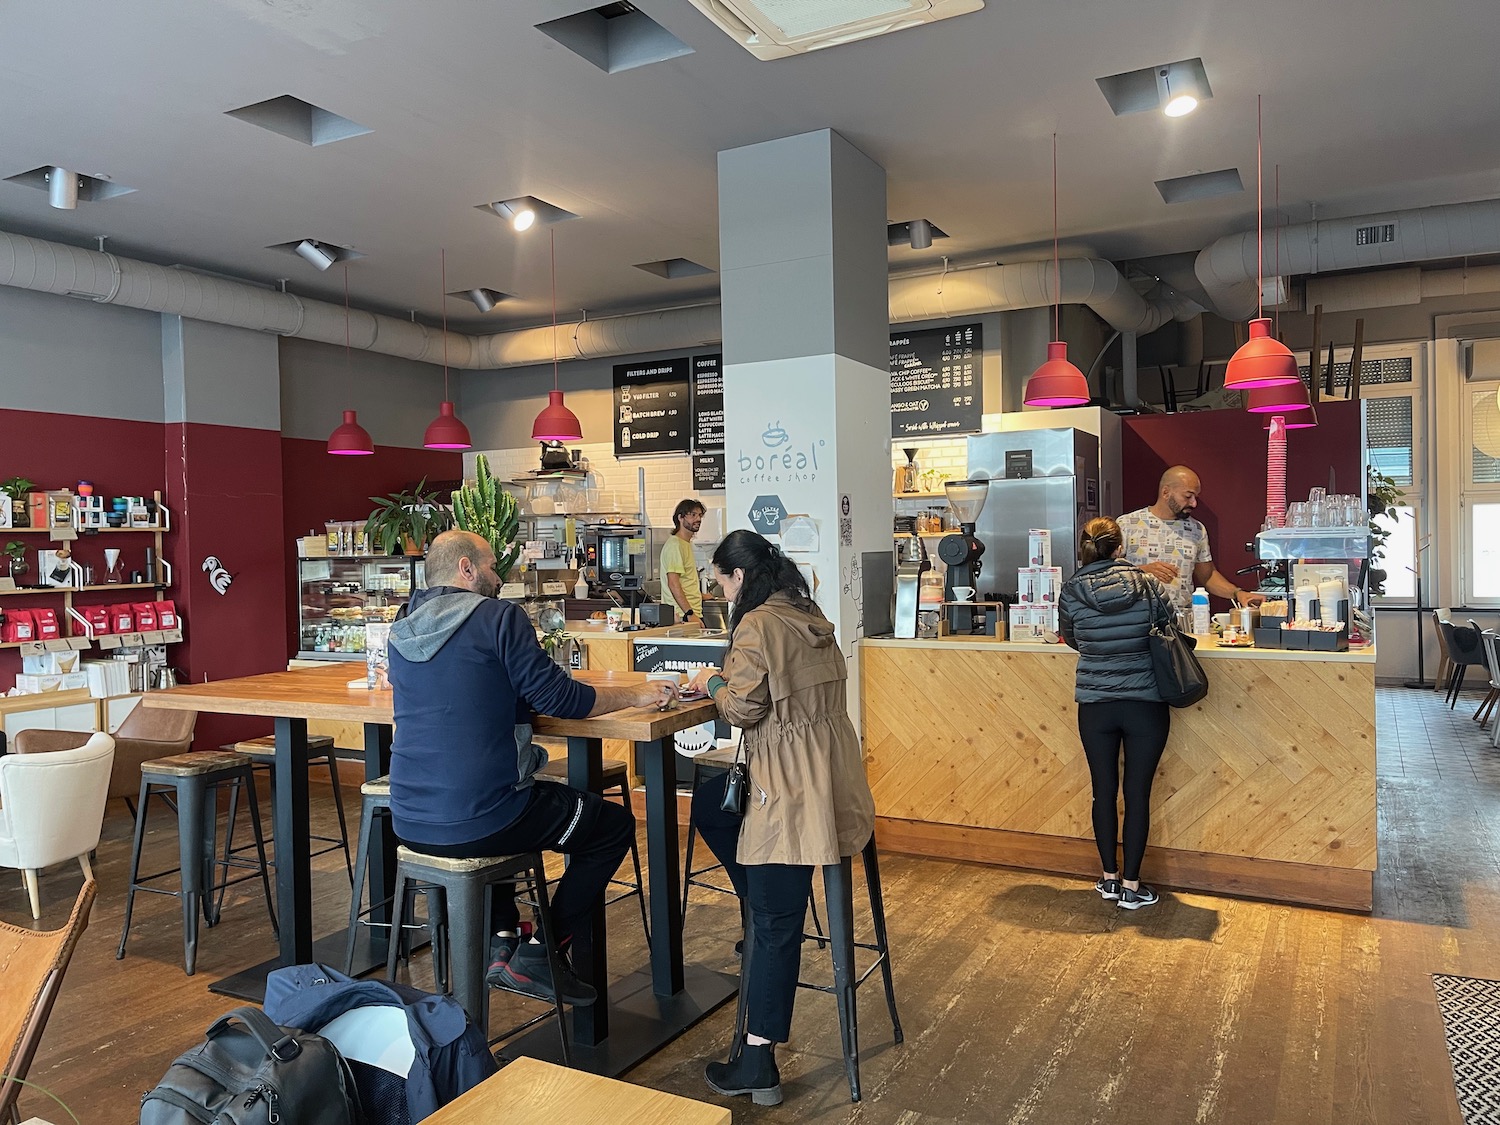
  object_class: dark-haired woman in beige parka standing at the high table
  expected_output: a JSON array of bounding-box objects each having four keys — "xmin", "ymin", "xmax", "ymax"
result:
[{"xmin": 693, "ymin": 531, "xmax": 875, "ymax": 1106}]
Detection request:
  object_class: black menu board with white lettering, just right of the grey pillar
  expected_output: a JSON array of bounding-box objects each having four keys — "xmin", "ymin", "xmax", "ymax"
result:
[{"xmin": 891, "ymin": 324, "xmax": 984, "ymax": 438}]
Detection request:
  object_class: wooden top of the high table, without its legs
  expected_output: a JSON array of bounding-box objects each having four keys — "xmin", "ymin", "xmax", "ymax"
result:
[{"xmin": 141, "ymin": 662, "xmax": 717, "ymax": 743}]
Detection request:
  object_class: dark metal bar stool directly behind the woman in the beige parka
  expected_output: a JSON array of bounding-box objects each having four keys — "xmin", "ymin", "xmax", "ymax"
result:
[{"xmin": 732, "ymin": 834, "xmax": 906, "ymax": 1101}]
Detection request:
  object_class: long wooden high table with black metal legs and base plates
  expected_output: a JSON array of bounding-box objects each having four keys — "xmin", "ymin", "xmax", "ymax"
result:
[{"xmin": 144, "ymin": 663, "xmax": 738, "ymax": 1074}]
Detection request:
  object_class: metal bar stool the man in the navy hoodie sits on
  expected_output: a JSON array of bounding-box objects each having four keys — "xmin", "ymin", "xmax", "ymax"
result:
[{"xmin": 386, "ymin": 846, "xmax": 573, "ymax": 1067}]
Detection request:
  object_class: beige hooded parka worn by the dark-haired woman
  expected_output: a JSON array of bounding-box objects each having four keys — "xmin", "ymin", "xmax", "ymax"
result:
[{"xmin": 714, "ymin": 591, "xmax": 875, "ymax": 867}]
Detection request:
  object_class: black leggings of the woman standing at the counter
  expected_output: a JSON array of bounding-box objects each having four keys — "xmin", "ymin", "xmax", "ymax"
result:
[{"xmin": 1079, "ymin": 699, "xmax": 1172, "ymax": 882}]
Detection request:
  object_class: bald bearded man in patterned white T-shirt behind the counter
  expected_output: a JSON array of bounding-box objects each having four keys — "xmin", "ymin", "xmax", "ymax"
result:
[{"xmin": 1118, "ymin": 465, "xmax": 1266, "ymax": 609}]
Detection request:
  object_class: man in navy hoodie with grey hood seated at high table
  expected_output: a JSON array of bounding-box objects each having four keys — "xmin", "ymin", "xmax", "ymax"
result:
[{"xmin": 389, "ymin": 531, "xmax": 677, "ymax": 1004}]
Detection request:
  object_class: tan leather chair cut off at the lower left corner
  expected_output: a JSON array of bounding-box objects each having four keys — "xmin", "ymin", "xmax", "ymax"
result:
[{"xmin": 0, "ymin": 879, "xmax": 99, "ymax": 1122}]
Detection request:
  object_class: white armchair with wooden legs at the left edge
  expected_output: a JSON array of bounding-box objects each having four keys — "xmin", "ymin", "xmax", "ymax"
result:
[{"xmin": 0, "ymin": 734, "xmax": 114, "ymax": 918}]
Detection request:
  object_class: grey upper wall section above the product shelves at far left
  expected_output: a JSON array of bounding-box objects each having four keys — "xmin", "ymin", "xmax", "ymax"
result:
[{"xmin": 0, "ymin": 287, "xmax": 165, "ymax": 422}]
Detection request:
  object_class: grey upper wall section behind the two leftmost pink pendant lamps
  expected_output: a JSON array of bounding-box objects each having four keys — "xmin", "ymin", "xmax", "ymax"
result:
[{"xmin": 281, "ymin": 339, "xmax": 462, "ymax": 449}]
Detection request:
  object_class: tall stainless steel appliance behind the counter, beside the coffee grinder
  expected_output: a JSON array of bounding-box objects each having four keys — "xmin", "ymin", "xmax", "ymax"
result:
[{"xmin": 944, "ymin": 429, "xmax": 1101, "ymax": 596}]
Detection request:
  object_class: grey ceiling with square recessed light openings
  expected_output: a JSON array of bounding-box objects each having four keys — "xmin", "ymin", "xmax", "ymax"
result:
[{"xmin": 0, "ymin": 0, "xmax": 1500, "ymax": 330}]
